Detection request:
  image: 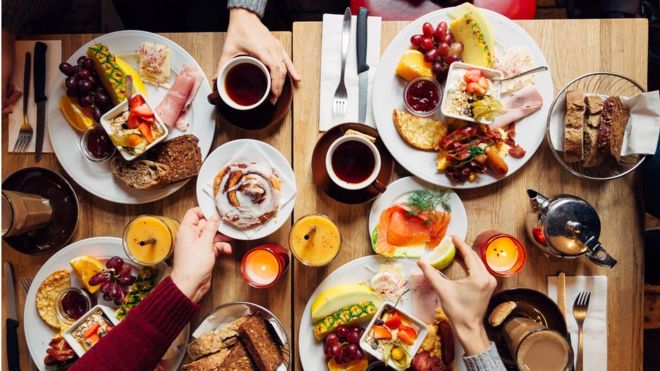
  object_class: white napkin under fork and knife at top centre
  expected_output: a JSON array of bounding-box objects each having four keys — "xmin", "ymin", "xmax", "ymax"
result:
[{"xmin": 319, "ymin": 14, "xmax": 381, "ymax": 131}]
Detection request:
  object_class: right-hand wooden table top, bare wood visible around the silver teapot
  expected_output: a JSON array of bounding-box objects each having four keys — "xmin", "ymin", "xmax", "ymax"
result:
[{"xmin": 292, "ymin": 20, "xmax": 648, "ymax": 370}]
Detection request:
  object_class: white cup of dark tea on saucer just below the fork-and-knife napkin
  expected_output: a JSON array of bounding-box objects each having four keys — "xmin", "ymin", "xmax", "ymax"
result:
[{"xmin": 325, "ymin": 135, "xmax": 385, "ymax": 192}]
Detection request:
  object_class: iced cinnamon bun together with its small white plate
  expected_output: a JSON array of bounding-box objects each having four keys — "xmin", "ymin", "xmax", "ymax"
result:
[{"xmin": 196, "ymin": 139, "xmax": 296, "ymax": 240}]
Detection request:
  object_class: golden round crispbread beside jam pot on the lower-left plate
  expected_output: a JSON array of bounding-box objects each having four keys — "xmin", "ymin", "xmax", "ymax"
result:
[{"xmin": 35, "ymin": 269, "xmax": 71, "ymax": 329}]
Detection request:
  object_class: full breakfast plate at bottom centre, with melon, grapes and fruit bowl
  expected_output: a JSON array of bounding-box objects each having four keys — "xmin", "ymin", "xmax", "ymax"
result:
[{"xmin": 298, "ymin": 255, "xmax": 465, "ymax": 371}]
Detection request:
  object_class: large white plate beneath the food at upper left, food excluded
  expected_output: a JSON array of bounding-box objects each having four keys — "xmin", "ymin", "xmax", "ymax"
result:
[{"xmin": 46, "ymin": 30, "xmax": 215, "ymax": 204}]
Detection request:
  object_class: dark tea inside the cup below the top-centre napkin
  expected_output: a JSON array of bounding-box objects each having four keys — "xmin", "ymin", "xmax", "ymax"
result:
[{"xmin": 332, "ymin": 140, "xmax": 376, "ymax": 184}]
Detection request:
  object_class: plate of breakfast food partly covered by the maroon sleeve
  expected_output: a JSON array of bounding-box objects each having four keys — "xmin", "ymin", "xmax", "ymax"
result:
[{"xmin": 23, "ymin": 237, "xmax": 190, "ymax": 370}]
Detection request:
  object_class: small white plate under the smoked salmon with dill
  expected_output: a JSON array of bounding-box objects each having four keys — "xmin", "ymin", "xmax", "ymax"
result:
[{"xmin": 369, "ymin": 176, "xmax": 467, "ymax": 253}]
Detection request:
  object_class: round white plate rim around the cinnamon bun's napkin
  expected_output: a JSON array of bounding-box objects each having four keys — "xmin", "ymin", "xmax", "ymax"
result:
[{"xmin": 196, "ymin": 139, "xmax": 296, "ymax": 240}]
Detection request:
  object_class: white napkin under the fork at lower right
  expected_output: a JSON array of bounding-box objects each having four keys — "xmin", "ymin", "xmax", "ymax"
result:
[{"xmin": 548, "ymin": 276, "xmax": 607, "ymax": 371}]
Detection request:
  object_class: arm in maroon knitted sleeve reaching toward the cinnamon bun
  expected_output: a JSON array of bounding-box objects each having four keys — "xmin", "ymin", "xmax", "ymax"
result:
[{"xmin": 70, "ymin": 208, "xmax": 231, "ymax": 371}]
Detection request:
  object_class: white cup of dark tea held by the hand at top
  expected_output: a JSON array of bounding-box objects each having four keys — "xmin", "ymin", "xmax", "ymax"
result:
[{"xmin": 216, "ymin": 55, "xmax": 270, "ymax": 111}]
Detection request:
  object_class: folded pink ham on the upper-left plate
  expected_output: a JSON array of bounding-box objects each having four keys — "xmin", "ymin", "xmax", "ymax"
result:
[{"xmin": 156, "ymin": 65, "xmax": 202, "ymax": 131}]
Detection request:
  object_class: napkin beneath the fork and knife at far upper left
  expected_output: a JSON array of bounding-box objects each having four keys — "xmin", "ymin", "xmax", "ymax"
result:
[{"xmin": 7, "ymin": 40, "xmax": 62, "ymax": 153}]
